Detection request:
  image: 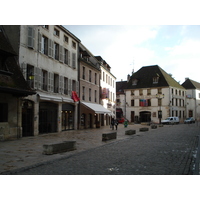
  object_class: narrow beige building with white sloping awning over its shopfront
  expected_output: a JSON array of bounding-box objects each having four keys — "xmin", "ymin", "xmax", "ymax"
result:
[{"xmin": 79, "ymin": 43, "xmax": 111, "ymax": 129}]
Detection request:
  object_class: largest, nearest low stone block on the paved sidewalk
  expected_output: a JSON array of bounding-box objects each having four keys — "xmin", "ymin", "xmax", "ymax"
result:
[{"xmin": 43, "ymin": 141, "xmax": 76, "ymax": 155}]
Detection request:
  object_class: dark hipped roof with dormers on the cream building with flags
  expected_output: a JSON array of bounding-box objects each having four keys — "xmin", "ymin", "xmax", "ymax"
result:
[{"xmin": 127, "ymin": 65, "xmax": 184, "ymax": 89}]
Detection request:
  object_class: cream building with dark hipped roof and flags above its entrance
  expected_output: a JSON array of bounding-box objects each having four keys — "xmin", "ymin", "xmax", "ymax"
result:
[{"xmin": 117, "ymin": 65, "xmax": 186, "ymax": 123}]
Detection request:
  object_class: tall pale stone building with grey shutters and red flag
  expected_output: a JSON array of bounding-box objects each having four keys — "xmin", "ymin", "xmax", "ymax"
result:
[{"xmin": 4, "ymin": 25, "xmax": 80, "ymax": 136}]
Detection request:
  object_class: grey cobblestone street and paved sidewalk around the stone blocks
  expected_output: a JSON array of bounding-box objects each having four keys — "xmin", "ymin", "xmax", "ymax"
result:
[{"xmin": 1, "ymin": 124, "xmax": 200, "ymax": 175}]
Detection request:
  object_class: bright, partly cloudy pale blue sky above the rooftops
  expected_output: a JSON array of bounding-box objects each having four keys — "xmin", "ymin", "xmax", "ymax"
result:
[{"xmin": 64, "ymin": 25, "xmax": 200, "ymax": 84}]
